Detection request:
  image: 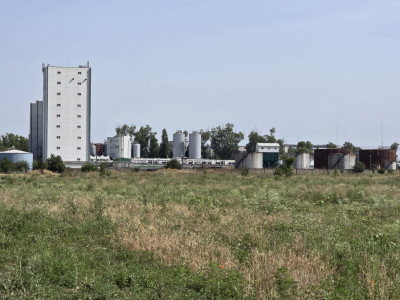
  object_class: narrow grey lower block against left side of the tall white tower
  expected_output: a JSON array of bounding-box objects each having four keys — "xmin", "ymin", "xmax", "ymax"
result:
[{"xmin": 29, "ymin": 100, "xmax": 43, "ymax": 160}]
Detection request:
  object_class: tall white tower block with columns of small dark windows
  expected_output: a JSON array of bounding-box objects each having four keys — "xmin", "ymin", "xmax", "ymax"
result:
[{"xmin": 42, "ymin": 62, "xmax": 91, "ymax": 162}]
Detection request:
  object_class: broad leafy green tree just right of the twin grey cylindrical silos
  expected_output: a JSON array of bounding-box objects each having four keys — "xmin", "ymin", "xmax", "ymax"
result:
[{"xmin": 211, "ymin": 123, "xmax": 244, "ymax": 159}]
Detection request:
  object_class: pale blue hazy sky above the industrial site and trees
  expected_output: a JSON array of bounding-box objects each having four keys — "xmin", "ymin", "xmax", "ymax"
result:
[{"xmin": 0, "ymin": 0, "xmax": 400, "ymax": 147}]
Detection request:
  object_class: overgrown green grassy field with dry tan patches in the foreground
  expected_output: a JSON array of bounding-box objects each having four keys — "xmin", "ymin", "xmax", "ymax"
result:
[{"xmin": 0, "ymin": 171, "xmax": 400, "ymax": 299}]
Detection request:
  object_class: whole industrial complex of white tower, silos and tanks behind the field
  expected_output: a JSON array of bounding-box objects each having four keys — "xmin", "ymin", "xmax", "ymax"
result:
[{"xmin": 0, "ymin": 62, "xmax": 397, "ymax": 170}]
